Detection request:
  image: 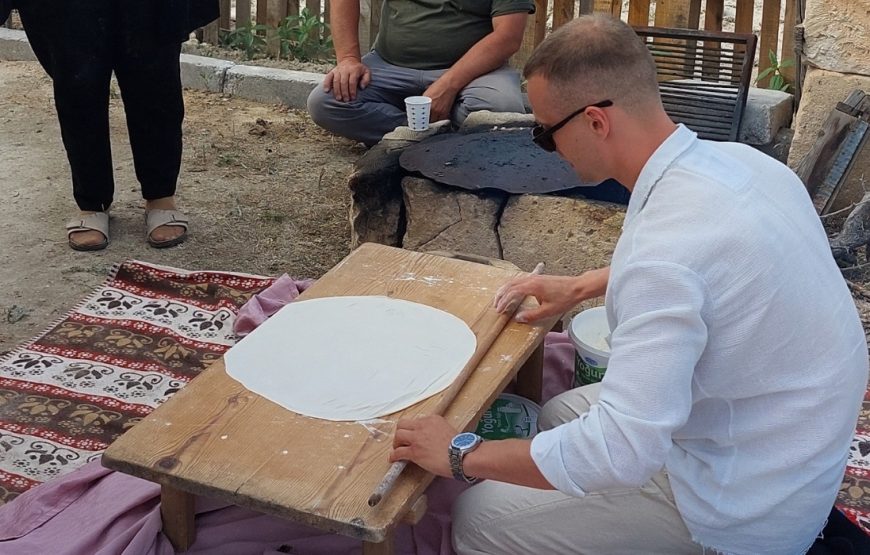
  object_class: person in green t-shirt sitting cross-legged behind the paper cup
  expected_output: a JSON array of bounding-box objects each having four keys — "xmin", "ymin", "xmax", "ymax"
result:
[{"xmin": 308, "ymin": 0, "xmax": 535, "ymax": 146}]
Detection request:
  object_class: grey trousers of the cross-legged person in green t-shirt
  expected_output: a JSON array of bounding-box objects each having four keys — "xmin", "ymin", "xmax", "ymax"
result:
[{"xmin": 308, "ymin": 51, "xmax": 525, "ymax": 146}]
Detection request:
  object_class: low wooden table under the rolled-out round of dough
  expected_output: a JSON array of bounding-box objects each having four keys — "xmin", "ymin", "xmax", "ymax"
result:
[{"xmin": 103, "ymin": 244, "xmax": 556, "ymax": 553}]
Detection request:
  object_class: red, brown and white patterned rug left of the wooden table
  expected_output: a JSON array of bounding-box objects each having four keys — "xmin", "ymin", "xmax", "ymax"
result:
[{"xmin": 0, "ymin": 261, "xmax": 273, "ymax": 504}]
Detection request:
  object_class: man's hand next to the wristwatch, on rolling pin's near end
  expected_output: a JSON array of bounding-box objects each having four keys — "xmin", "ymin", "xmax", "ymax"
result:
[{"xmin": 390, "ymin": 416, "xmax": 457, "ymax": 478}]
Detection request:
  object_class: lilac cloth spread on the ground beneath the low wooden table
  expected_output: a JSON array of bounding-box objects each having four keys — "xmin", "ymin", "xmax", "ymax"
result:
[{"xmin": 0, "ymin": 275, "xmax": 574, "ymax": 555}]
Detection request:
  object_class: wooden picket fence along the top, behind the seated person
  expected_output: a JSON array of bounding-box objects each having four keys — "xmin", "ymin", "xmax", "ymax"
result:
[{"xmin": 203, "ymin": 0, "xmax": 801, "ymax": 86}]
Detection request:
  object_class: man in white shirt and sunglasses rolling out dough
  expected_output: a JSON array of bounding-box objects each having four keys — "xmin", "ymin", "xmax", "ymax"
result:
[{"xmin": 391, "ymin": 16, "xmax": 868, "ymax": 555}]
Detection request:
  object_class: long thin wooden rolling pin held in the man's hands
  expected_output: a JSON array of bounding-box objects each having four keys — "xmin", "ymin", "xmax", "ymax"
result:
[{"xmin": 369, "ymin": 262, "xmax": 544, "ymax": 507}]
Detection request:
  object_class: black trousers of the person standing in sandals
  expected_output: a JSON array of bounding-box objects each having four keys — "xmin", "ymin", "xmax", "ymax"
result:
[{"xmin": 18, "ymin": 0, "xmax": 184, "ymax": 211}]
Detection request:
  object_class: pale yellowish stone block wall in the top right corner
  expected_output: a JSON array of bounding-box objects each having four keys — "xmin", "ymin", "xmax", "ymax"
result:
[{"xmin": 788, "ymin": 0, "xmax": 870, "ymax": 168}]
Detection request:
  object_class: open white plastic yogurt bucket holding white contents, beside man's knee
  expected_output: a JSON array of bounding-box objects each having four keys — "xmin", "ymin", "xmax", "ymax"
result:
[{"xmin": 568, "ymin": 306, "xmax": 610, "ymax": 387}]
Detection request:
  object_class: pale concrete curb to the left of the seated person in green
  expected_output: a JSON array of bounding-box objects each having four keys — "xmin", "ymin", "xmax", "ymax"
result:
[{"xmin": 0, "ymin": 27, "xmax": 324, "ymax": 110}]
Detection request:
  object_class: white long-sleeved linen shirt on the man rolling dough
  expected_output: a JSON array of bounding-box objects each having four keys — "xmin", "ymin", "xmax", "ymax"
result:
[{"xmin": 531, "ymin": 126, "xmax": 868, "ymax": 555}]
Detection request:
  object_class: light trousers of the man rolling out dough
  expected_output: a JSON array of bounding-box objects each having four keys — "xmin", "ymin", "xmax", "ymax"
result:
[{"xmin": 453, "ymin": 384, "xmax": 703, "ymax": 555}]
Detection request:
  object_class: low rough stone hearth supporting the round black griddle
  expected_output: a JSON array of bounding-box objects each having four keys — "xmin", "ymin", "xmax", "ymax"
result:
[{"xmin": 349, "ymin": 112, "xmax": 625, "ymax": 275}]
